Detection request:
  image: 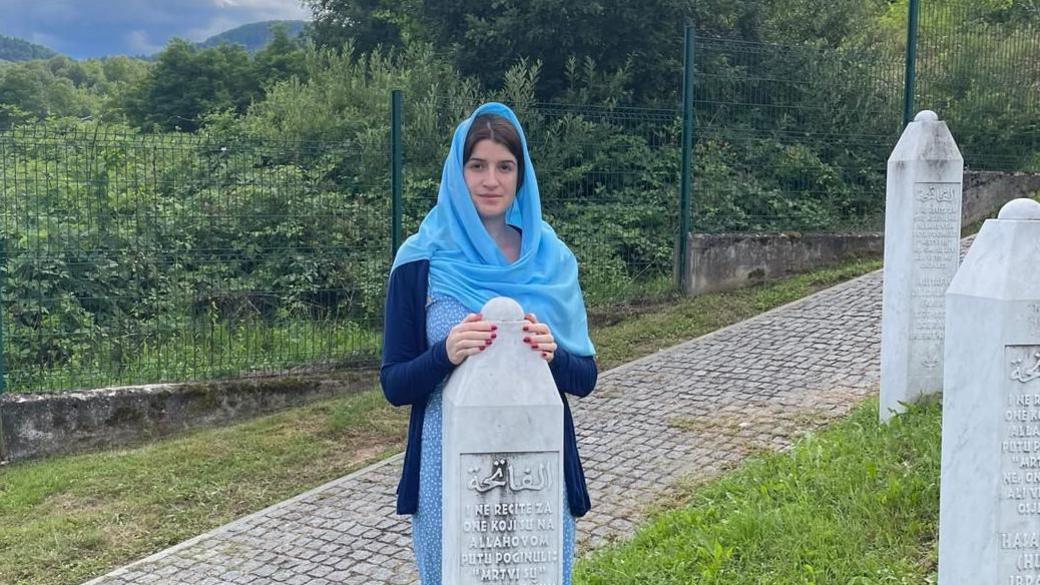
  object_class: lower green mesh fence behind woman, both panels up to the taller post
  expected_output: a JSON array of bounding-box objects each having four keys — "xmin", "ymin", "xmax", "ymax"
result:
[{"xmin": 0, "ymin": 96, "xmax": 678, "ymax": 391}]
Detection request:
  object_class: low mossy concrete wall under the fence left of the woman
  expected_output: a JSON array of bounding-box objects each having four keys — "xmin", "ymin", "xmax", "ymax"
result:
[{"xmin": 0, "ymin": 371, "xmax": 375, "ymax": 461}]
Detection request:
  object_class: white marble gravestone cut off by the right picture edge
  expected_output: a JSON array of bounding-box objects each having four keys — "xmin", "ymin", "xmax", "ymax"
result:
[{"xmin": 939, "ymin": 199, "xmax": 1040, "ymax": 585}]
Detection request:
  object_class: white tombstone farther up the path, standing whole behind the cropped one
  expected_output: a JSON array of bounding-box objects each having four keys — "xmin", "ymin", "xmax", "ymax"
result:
[{"xmin": 880, "ymin": 109, "xmax": 964, "ymax": 422}]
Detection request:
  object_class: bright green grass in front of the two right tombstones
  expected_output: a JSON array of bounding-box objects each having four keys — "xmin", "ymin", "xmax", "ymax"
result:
[{"xmin": 575, "ymin": 400, "xmax": 941, "ymax": 585}]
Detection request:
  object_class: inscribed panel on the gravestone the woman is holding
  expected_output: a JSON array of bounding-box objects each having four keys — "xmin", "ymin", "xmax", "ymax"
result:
[{"xmin": 459, "ymin": 452, "xmax": 563, "ymax": 585}]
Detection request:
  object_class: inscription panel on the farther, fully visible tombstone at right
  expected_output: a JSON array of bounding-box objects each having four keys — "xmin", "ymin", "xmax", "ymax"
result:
[{"xmin": 910, "ymin": 183, "xmax": 961, "ymax": 345}]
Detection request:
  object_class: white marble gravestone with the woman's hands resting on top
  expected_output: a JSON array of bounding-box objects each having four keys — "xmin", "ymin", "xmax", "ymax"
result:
[{"xmin": 441, "ymin": 298, "xmax": 564, "ymax": 585}]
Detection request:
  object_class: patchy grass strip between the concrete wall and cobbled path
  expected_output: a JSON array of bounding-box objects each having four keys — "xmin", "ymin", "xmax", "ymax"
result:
[{"xmin": 0, "ymin": 252, "xmax": 880, "ymax": 585}]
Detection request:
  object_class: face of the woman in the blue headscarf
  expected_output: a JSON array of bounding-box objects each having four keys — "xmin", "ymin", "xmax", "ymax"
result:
[{"xmin": 464, "ymin": 139, "xmax": 517, "ymax": 221}]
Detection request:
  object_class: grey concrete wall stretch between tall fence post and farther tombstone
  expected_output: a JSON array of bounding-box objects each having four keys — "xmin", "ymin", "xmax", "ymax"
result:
[{"xmin": 684, "ymin": 233, "xmax": 884, "ymax": 295}]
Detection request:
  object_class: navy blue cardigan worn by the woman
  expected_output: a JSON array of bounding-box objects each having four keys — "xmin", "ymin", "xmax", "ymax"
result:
[{"xmin": 380, "ymin": 260, "xmax": 597, "ymax": 516}]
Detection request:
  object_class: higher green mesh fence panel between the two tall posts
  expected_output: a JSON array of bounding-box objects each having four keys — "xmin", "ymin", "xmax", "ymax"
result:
[{"xmin": 693, "ymin": 37, "xmax": 903, "ymax": 233}]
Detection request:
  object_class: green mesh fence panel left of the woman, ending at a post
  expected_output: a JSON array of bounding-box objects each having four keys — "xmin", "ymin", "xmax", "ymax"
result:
[{"xmin": 0, "ymin": 126, "xmax": 390, "ymax": 391}]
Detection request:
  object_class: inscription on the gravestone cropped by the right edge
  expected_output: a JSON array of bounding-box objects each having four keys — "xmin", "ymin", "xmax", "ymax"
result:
[{"xmin": 997, "ymin": 346, "xmax": 1040, "ymax": 585}]
